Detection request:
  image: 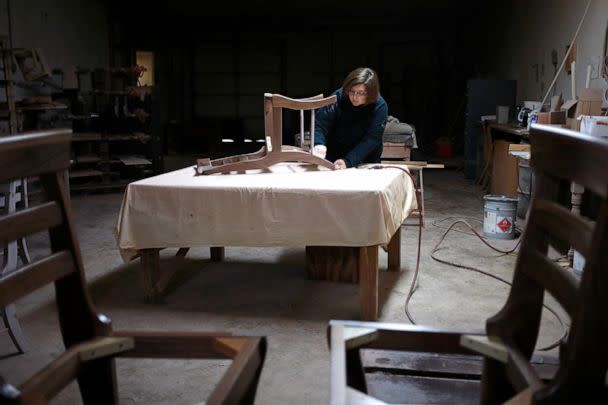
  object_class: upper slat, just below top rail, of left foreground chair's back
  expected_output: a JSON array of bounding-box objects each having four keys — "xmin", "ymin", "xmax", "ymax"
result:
[{"xmin": 0, "ymin": 201, "xmax": 63, "ymax": 241}]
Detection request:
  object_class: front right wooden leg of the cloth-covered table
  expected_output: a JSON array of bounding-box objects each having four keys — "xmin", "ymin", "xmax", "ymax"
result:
[{"xmin": 359, "ymin": 246, "xmax": 378, "ymax": 321}]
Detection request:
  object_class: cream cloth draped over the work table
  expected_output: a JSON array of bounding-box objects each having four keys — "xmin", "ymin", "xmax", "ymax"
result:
[{"xmin": 116, "ymin": 164, "xmax": 416, "ymax": 261}]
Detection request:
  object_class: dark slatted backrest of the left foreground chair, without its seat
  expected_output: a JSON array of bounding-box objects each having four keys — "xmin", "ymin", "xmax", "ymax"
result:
[{"xmin": 0, "ymin": 130, "xmax": 109, "ymax": 345}]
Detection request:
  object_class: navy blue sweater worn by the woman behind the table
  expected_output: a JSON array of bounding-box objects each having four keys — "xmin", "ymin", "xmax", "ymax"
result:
[{"xmin": 315, "ymin": 88, "xmax": 388, "ymax": 167}]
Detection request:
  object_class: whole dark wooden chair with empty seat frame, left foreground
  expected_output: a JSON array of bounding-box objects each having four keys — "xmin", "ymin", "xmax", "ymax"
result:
[{"xmin": 0, "ymin": 133, "xmax": 266, "ymax": 404}]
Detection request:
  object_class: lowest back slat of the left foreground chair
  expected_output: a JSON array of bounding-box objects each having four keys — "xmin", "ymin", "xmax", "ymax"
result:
[{"xmin": 0, "ymin": 251, "xmax": 76, "ymax": 307}]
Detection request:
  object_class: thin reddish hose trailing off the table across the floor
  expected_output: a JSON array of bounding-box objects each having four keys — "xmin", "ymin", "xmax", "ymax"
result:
[{"xmin": 360, "ymin": 165, "xmax": 568, "ymax": 351}]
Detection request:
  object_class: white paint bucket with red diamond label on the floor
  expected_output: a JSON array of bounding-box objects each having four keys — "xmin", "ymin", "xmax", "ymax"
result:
[{"xmin": 483, "ymin": 194, "xmax": 517, "ymax": 239}]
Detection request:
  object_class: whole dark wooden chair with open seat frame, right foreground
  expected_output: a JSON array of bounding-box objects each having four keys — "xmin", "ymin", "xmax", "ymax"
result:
[{"xmin": 330, "ymin": 125, "xmax": 608, "ymax": 404}]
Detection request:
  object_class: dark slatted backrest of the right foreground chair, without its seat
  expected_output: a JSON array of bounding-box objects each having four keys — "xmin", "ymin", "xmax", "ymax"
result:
[{"xmin": 482, "ymin": 125, "xmax": 608, "ymax": 403}]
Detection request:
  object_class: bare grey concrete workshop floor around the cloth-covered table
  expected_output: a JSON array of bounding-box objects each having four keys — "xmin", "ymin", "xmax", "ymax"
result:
[{"xmin": 0, "ymin": 166, "xmax": 562, "ymax": 404}]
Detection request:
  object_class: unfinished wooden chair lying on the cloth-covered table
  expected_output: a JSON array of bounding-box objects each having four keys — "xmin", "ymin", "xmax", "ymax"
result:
[{"xmin": 197, "ymin": 93, "xmax": 336, "ymax": 174}]
